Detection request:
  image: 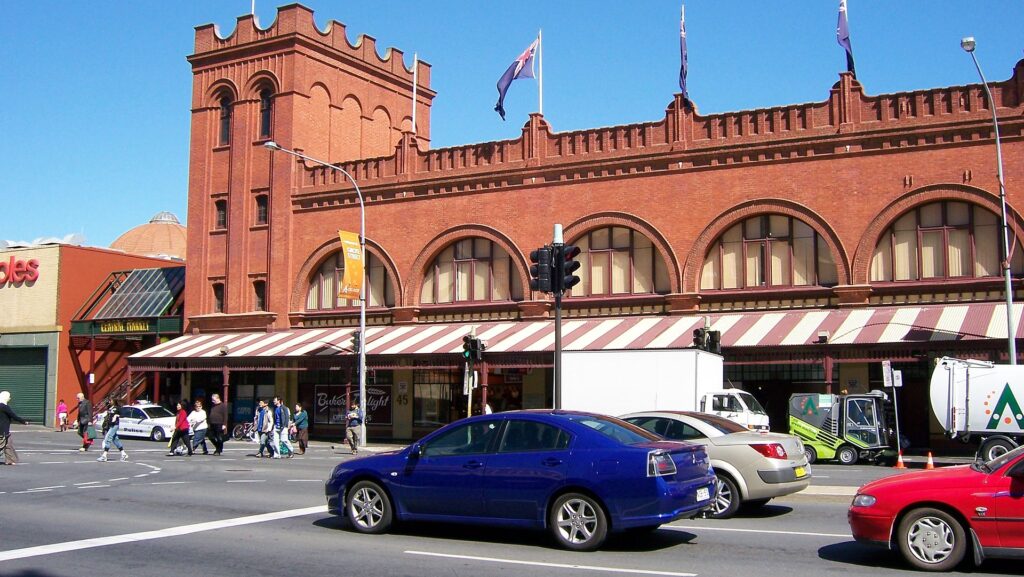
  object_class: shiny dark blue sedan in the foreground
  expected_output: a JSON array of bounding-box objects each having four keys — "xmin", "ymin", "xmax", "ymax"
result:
[{"xmin": 325, "ymin": 410, "xmax": 716, "ymax": 550}]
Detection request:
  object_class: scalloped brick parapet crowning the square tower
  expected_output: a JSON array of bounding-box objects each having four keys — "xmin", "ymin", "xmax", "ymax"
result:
[{"xmin": 189, "ymin": 4, "xmax": 430, "ymax": 90}]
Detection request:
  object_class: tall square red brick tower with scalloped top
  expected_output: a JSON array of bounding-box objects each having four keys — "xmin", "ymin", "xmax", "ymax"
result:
[{"xmin": 185, "ymin": 4, "xmax": 434, "ymax": 330}]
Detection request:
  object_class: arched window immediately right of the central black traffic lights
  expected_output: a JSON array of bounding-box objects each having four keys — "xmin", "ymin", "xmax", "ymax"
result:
[{"xmin": 571, "ymin": 226, "xmax": 670, "ymax": 296}]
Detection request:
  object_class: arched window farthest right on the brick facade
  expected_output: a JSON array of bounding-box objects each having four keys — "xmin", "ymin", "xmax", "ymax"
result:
[{"xmin": 870, "ymin": 201, "xmax": 1024, "ymax": 282}]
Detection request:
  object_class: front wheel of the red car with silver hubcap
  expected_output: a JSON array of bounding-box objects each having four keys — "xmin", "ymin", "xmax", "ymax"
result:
[{"xmin": 896, "ymin": 507, "xmax": 967, "ymax": 571}]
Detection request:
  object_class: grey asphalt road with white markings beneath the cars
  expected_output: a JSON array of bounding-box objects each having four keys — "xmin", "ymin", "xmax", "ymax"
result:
[{"xmin": 0, "ymin": 428, "xmax": 1019, "ymax": 577}]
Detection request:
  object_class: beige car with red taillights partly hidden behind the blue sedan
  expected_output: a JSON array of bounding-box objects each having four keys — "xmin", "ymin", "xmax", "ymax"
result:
[{"xmin": 621, "ymin": 411, "xmax": 811, "ymax": 519}]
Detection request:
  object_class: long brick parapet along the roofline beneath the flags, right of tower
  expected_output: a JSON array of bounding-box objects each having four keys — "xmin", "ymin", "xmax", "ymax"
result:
[{"xmin": 286, "ymin": 60, "xmax": 1024, "ymax": 208}]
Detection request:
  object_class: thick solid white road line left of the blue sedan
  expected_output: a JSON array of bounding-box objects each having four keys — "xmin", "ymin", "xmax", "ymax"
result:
[{"xmin": 0, "ymin": 505, "xmax": 327, "ymax": 562}]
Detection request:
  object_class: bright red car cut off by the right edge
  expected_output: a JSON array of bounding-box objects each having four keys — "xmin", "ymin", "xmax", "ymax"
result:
[{"xmin": 849, "ymin": 447, "xmax": 1024, "ymax": 571}]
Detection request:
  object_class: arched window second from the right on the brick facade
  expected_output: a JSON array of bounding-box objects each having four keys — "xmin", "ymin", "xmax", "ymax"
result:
[{"xmin": 700, "ymin": 214, "xmax": 838, "ymax": 290}]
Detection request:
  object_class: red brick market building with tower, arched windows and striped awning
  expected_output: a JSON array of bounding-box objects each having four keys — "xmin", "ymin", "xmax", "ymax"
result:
[{"xmin": 132, "ymin": 5, "xmax": 1024, "ymax": 446}]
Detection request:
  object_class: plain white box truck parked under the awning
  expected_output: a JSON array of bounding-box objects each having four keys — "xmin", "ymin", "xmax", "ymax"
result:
[{"xmin": 562, "ymin": 348, "xmax": 768, "ymax": 430}]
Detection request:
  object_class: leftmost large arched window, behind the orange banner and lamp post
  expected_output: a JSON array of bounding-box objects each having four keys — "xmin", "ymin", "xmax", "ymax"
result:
[{"xmin": 306, "ymin": 251, "xmax": 394, "ymax": 311}]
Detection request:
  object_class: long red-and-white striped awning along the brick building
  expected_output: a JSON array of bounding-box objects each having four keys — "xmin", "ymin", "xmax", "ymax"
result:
[{"xmin": 131, "ymin": 302, "xmax": 1024, "ymax": 360}]
